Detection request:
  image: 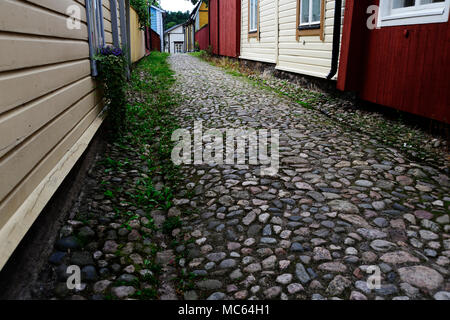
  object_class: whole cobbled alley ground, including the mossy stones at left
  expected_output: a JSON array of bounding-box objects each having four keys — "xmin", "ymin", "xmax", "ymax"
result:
[{"xmin": 26, "ymin": 54, "xmax": 450, "ymax": 300}]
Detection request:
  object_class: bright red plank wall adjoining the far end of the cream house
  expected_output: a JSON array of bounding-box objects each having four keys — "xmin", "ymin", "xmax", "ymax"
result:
[{"xmin": 209, "ymin": 0, "xmax": 241, "ymax": 58}]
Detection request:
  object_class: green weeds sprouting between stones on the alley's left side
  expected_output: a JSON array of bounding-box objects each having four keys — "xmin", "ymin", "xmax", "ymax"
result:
[{"xmin": 90, "ymin": 52, "xmax": 181, "ymax": 299}]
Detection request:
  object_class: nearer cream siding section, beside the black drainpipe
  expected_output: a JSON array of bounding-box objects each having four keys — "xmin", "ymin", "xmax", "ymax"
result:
[{"xmin": 277, "ymin": 0, "xmax": 346, "ymax": 78}]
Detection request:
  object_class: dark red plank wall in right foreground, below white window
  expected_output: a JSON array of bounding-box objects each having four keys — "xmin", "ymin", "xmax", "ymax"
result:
[{"xmin": 338, "ymin": 0, "xmax": 450, "ymax": 123}]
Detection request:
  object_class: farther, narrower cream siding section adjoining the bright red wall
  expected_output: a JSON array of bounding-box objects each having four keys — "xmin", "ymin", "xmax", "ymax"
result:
[{"xmin": 240, "ymin": 0, "xmax": 277, "ymax": 63}]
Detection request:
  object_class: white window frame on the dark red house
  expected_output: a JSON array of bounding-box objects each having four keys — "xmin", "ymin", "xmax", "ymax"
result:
[{"xmin": 378, "ymin": 0, "xmax": 450, "ymax": 27}]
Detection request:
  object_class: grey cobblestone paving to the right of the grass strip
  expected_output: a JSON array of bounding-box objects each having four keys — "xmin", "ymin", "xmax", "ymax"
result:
[{"xmin": 169, "ymin": 55, "xmax": 450, "ymax": 300}]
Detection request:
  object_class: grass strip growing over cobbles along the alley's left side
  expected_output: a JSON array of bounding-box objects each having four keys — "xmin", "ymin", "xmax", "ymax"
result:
[{"xmin": 76, "ymin": 52, "xmax": 181, "ymax": 299}]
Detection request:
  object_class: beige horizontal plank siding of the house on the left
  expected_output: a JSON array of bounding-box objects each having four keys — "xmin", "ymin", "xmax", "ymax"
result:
[{"xmin": 0, "ymin": 0, "xmax": 106, "ymax": 269}]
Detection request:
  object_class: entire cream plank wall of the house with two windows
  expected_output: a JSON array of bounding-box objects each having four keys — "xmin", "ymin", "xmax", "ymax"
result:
[{"xmin": 241, "ymin": 0, "xmax": 345, "ymax": 78}]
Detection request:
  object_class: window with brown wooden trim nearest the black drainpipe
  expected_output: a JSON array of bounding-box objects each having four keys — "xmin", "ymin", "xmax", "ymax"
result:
[{"xmin": 297, "ymin": 0, "xmax": 325, "ymax": 40}]
